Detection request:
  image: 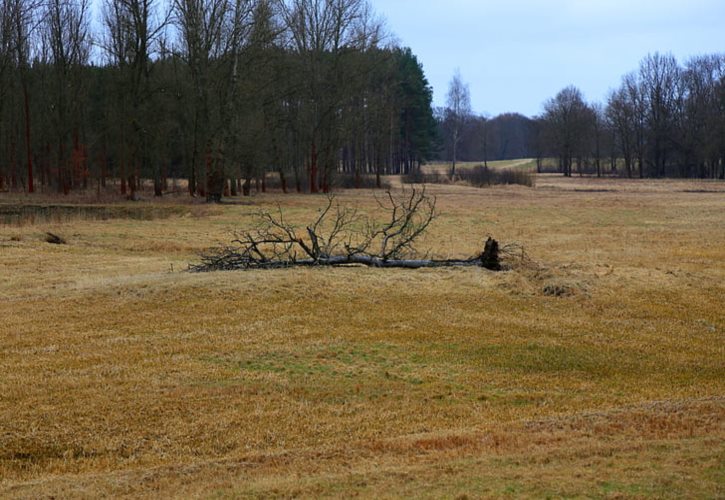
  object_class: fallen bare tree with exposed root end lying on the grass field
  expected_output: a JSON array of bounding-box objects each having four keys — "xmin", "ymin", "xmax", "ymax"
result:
[{"xmin": 189, "ymin": 188, "xmax": 501, "ymax": 272}]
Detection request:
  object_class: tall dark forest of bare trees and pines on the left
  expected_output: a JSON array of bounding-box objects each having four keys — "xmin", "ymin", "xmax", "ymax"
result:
[{"xmin": 0, "ymin": 0, "xmax": 436, "ymax": 200}]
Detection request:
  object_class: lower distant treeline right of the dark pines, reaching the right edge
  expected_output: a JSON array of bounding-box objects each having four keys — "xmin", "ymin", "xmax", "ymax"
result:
[{"xmin": 436, "ymin": 54, "xmax": 725, "ymax": 179}]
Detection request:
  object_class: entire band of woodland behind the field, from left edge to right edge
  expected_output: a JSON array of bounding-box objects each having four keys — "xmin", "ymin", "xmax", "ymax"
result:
[{"xmin": 0, "ymin": 0, "xmax": 725, "ymax": 201}]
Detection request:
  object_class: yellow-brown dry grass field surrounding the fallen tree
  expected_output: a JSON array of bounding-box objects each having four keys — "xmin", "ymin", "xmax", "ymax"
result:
[{"xmin": 0, "ymin": 176, "xmax": 725, "ymax": 498}]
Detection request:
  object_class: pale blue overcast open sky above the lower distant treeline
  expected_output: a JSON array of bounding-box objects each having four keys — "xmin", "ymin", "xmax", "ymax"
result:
[{"xmin": 371, "ymin": 0, "xmax": 725, "ymax": 116}]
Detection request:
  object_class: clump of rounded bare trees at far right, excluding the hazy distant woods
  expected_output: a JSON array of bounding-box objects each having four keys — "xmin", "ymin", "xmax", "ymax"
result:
[{"xmin": 532, "ymin": 54, "xmax": 725, "ymax": 179}]
